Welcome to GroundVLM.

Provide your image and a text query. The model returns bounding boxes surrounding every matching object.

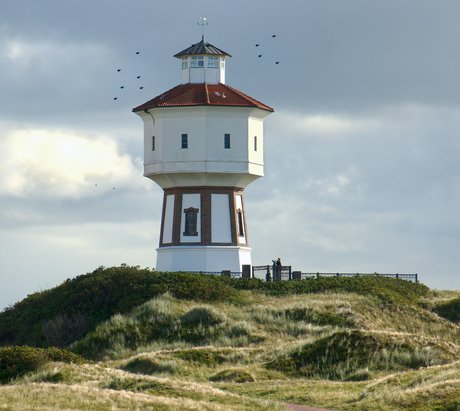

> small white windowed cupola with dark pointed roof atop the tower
[174,37,231,84]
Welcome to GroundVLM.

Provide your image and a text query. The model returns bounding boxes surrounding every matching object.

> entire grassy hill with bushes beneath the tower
[0,266,460,411]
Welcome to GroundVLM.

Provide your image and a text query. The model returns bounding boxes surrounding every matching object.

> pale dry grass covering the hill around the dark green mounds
[0,292,460,411]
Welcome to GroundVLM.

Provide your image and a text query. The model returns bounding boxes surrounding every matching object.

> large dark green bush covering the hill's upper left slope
[0,265,241,347]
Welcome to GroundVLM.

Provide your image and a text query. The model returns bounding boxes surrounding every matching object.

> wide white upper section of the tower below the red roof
[138,106,269,188]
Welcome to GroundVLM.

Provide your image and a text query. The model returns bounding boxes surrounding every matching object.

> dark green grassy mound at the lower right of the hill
[267,330,449,380]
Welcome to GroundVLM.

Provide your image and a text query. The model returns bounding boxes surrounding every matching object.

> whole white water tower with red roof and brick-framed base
[133,38,273,272]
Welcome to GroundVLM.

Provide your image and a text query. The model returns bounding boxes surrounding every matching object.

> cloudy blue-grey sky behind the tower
[0,0,460,310]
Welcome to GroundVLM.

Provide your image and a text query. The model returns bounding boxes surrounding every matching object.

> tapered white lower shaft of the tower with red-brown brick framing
[156,186,251,271]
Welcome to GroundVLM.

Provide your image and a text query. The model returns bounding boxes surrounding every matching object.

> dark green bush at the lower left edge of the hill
[0,346,84,384]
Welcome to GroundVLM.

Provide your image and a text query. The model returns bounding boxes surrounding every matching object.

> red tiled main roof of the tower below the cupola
[133,83,274,112]
